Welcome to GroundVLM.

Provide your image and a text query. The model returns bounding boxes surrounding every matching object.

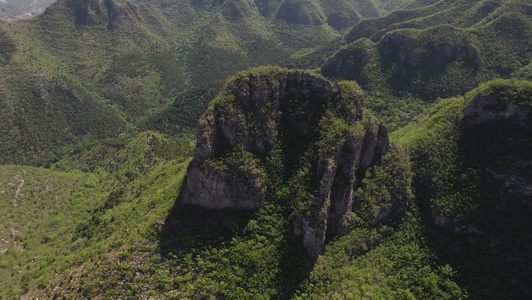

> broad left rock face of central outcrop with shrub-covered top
[182,71,333,209]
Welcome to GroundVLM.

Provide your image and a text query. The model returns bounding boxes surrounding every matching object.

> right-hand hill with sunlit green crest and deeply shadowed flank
[392,79,532,299]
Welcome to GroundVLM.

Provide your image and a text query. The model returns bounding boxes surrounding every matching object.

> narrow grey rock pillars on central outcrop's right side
[294,119,391,257]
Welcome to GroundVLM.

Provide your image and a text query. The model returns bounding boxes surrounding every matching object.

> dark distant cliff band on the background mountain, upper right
[322,26,482,100]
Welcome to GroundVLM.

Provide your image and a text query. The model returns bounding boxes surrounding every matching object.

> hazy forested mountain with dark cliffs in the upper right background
[322,1,532,127]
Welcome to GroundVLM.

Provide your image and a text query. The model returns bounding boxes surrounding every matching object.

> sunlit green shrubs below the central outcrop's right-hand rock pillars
[300,207,468,299]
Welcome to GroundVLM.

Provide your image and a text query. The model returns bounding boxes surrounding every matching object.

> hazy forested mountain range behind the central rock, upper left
[0,0,408,165]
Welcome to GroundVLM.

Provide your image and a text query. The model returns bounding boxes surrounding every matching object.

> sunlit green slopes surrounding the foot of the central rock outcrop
[0,78,525,298]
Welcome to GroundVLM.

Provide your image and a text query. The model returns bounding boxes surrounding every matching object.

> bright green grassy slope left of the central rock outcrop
[0,132,191,297]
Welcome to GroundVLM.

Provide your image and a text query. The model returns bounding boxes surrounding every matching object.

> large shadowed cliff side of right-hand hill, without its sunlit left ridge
[420,79,532,294]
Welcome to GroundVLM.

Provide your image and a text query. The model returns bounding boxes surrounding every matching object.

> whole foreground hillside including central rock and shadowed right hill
[0,69,532,298]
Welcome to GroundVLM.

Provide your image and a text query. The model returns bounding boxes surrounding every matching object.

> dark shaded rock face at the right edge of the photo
[460,87,532,207]
